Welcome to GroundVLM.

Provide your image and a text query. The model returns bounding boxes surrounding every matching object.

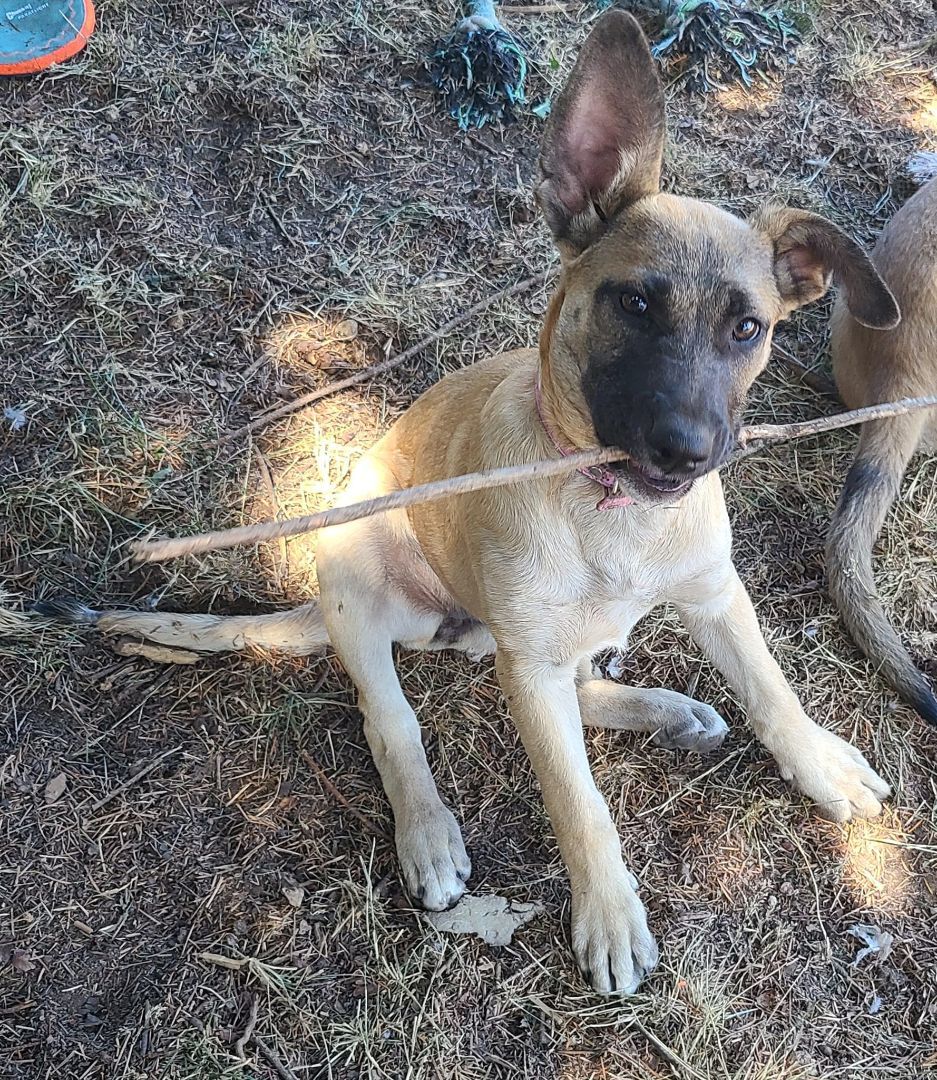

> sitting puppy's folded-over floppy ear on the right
[751,206,901,330]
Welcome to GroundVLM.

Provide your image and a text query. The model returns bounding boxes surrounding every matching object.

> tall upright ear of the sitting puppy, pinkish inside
[537,11,665,259]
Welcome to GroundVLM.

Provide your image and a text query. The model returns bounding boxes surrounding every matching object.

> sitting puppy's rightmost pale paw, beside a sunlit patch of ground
[775,725,892,821]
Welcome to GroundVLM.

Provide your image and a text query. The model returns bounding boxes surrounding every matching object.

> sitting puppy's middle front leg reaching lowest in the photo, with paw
[497,647,657,994]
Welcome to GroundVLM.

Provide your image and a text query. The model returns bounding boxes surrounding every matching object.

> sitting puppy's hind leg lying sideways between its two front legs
[576,661,729,753]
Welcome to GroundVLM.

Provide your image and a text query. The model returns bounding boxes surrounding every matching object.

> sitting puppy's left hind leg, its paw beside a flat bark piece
[323,582,472,912]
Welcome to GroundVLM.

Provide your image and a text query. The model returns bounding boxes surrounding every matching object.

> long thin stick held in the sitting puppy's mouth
[131,396,937,563]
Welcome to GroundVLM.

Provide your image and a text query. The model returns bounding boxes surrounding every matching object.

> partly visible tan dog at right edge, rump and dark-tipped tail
[827,168,937,725]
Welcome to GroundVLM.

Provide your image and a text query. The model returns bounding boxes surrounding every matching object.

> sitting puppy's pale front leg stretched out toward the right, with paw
[675,566,890,821]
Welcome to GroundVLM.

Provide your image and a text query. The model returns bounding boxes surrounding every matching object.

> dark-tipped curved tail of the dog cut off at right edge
[827,413,937,726]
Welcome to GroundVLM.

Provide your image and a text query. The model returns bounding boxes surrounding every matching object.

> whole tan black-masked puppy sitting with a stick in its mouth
[45,11,898,994]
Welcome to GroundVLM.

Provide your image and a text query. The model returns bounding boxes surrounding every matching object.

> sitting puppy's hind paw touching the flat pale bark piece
[396,802,472,912]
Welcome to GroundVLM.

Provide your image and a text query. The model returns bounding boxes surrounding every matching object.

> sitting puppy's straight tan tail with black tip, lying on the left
[33,599,328,656]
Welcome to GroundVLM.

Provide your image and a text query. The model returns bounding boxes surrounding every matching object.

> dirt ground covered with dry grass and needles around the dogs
[0,0,937,1080]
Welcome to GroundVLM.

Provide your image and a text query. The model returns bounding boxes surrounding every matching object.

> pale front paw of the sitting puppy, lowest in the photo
[572,867,657,994]
